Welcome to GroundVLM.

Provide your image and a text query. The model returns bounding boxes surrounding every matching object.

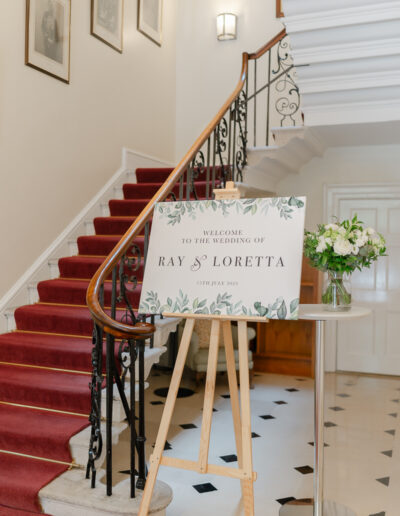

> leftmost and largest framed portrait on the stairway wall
[25,0,71,83]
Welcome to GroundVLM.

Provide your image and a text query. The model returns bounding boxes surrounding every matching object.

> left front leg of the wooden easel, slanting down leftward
[139,319,195,516]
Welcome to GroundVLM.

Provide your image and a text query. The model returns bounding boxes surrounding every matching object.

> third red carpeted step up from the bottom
[0,364,91,414]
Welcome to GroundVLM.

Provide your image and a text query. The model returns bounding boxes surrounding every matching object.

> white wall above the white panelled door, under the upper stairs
[277,145,400,230]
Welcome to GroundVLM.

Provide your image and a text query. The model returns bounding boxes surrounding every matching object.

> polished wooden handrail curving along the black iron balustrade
[86,30,286,339]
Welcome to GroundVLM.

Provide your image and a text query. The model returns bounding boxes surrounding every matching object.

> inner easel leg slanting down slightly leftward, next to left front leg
[199,319,221,473]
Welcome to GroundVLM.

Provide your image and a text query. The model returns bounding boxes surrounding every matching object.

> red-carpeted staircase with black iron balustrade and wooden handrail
[0,27,312,516]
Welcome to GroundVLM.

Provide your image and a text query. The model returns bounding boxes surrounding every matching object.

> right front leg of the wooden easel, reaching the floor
[238,321,254,516]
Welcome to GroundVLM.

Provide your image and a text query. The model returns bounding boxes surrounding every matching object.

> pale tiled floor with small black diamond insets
[111,371,400,516]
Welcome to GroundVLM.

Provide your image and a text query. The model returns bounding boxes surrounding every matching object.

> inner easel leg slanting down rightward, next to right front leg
[222,321,243,474]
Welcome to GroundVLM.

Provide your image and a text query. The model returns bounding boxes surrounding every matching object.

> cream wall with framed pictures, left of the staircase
[0,0,176,297]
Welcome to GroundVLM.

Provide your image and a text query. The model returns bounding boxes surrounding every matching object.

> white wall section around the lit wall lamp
[176,0,283,160]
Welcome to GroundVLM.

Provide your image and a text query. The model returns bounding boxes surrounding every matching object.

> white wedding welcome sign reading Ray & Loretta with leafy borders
[139,197,305,319]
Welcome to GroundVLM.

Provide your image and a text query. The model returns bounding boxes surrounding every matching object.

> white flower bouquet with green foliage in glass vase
[304,215,386,310]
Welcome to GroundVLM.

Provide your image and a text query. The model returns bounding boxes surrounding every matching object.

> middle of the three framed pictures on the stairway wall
[91,0,124,54]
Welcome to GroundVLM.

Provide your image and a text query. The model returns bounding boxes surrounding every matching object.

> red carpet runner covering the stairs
[0,168,206,516]
